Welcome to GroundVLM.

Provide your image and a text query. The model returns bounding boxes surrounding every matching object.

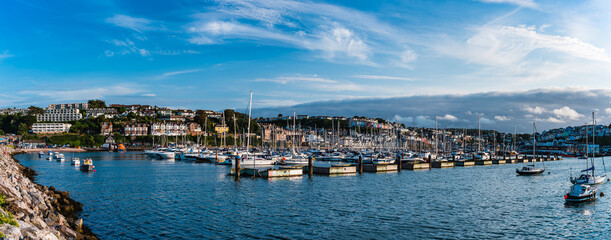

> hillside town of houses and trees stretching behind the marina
[0,100,611,156]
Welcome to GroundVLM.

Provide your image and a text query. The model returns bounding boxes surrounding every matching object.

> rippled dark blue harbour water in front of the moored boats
[16,152,611,239]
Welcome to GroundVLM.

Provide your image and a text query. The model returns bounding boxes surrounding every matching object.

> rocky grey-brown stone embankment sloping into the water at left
[0,147,98,240]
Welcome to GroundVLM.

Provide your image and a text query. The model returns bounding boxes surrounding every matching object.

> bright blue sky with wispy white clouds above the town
[0,0,611,132]
